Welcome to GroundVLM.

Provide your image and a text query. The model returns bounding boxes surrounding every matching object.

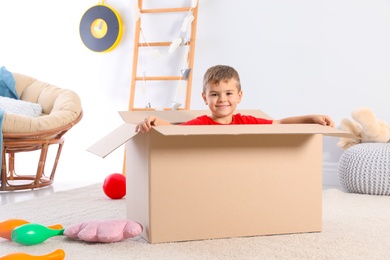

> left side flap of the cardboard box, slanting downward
[87,124,137,158]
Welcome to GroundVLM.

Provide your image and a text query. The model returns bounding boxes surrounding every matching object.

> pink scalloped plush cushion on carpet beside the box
[64,220,143,243]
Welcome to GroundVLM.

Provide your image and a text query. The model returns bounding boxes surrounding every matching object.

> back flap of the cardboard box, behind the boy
[119,110,272,124]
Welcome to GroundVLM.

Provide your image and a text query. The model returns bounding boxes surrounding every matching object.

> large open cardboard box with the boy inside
[88,111,350,243]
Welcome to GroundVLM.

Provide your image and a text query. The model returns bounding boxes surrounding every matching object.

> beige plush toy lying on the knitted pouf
[337,107,390,149]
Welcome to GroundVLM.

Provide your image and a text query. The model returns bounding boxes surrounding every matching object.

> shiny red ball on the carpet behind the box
[103,173,126,199]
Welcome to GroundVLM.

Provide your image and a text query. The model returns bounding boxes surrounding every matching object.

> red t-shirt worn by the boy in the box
[180,114,273,125]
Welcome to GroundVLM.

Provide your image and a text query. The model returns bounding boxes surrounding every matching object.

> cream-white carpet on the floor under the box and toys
[0,184,390,260]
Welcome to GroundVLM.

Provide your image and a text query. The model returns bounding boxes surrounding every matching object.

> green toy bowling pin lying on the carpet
[11,223,64,246]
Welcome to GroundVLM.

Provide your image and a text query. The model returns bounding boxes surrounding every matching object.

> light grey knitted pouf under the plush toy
[338,143,390,195]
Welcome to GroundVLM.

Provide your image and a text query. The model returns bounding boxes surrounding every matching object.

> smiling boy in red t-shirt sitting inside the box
[135,65,334,133]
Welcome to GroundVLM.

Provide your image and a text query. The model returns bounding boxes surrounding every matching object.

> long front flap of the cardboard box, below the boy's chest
[154,124,354,138]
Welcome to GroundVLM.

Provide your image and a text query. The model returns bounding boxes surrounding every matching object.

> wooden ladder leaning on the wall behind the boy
[129,0,198,111]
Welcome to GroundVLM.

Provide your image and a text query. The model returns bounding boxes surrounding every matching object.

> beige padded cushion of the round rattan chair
[3,73,82,133]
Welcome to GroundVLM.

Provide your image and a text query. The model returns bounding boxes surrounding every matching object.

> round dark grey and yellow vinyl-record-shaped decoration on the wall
[80,1,123,52]
